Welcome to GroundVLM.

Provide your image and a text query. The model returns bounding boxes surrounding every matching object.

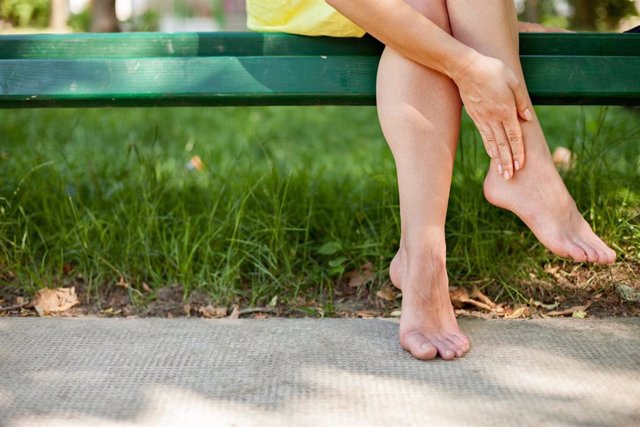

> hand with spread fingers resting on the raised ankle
[453,54,533,180]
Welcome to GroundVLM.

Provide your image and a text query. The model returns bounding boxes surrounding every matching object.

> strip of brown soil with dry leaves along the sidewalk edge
[0,262,640,319]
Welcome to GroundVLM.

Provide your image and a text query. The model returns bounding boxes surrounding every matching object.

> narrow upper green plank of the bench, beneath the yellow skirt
[0,33,640,60]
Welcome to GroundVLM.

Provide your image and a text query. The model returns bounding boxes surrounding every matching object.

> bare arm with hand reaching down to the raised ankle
[327,0,533,176]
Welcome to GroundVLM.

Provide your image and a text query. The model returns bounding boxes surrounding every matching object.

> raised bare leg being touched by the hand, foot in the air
[447,0,615,264]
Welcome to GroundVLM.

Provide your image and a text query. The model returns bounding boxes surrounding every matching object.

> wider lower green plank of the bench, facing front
[0,56,640,108]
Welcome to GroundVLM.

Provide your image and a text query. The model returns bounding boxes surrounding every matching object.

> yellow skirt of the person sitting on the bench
[247,0,365,37]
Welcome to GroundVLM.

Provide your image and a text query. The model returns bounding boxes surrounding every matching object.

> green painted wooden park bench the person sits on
[0,33,640,108]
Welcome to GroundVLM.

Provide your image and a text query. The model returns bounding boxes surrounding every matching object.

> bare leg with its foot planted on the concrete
[377,0,469,359]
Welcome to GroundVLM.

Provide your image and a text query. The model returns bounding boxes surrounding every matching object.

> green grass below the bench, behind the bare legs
[0,107,640,312]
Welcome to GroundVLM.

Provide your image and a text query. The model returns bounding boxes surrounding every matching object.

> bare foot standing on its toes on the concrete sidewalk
[389,245,469,360]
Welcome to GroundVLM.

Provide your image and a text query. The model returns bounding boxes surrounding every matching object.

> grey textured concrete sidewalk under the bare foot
[0,318,640,427]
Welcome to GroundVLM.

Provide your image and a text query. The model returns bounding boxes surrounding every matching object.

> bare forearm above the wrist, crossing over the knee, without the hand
[327,0,478,77]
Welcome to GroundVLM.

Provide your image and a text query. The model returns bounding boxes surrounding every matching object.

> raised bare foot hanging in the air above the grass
[484,118,616,264]
